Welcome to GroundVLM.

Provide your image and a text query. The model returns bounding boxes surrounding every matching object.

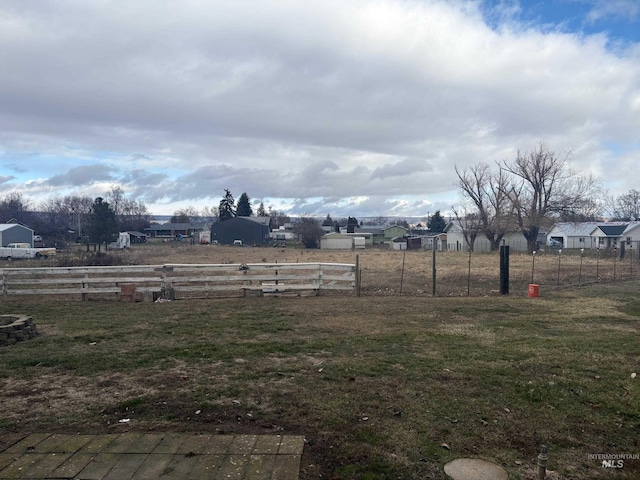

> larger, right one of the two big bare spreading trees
[501,143,599,253]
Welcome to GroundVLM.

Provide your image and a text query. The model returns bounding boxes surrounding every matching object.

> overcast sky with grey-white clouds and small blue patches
[0,0,640,217]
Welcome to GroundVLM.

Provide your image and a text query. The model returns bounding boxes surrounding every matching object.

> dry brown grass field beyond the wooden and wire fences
[58,241,640,296]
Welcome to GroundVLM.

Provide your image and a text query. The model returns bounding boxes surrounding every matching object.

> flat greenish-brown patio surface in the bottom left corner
[0,432,304,480]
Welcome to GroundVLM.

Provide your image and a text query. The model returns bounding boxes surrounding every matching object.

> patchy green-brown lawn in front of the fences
[0,264,640,479]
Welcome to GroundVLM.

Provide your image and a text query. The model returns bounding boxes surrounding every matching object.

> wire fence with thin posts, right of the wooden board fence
[359,249,640,296]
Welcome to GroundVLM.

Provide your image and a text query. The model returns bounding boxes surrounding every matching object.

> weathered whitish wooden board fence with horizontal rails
[0,263,358,300]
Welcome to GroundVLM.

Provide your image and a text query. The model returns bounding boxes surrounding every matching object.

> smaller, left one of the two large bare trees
[454,163,515,252]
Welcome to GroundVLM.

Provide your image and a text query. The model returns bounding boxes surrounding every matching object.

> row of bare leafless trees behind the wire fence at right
[453,143,640,253]
